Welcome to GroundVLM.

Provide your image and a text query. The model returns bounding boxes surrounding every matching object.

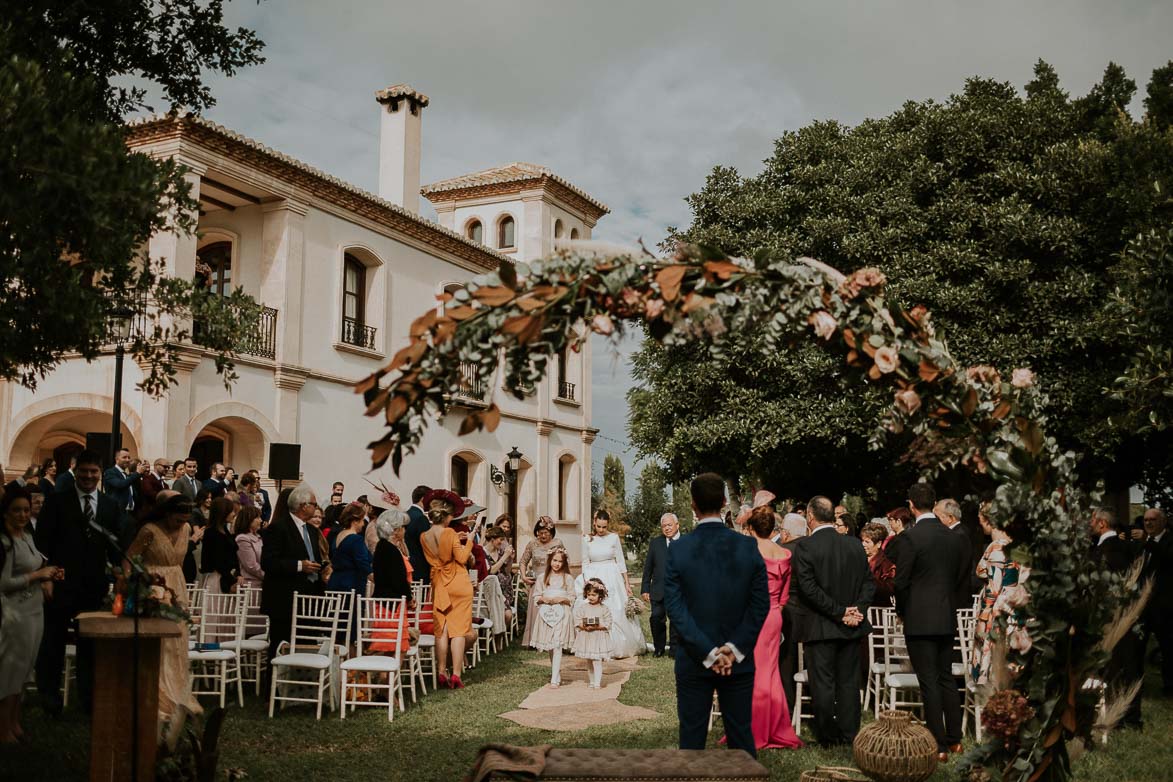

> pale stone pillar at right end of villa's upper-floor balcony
[260,198,308,366]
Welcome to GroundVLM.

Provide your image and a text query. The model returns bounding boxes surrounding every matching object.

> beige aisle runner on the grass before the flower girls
[500,655,659,730]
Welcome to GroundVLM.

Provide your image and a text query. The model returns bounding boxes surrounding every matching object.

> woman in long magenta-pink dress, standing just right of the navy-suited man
[746,506,802,749]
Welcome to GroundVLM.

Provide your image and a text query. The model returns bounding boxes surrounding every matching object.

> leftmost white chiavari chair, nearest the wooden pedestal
[188,592,244,708]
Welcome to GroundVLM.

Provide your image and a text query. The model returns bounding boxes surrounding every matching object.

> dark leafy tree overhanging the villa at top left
[0,0,262,393]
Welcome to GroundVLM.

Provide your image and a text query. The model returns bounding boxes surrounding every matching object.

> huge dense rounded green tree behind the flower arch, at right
[630,62,1173,496]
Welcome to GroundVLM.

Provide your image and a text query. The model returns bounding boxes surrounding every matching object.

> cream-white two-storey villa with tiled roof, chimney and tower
[0,84,608,559]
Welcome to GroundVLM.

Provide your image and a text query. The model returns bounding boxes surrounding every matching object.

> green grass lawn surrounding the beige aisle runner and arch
[9,647,1173,782]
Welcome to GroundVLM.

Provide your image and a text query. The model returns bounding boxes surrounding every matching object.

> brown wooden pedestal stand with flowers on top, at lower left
[77,611,183,782]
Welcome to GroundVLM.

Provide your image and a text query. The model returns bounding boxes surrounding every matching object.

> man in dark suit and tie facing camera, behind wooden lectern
[35,450,123,714]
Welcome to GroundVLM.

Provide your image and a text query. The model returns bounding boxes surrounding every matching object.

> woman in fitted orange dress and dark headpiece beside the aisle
[420,489,473,689]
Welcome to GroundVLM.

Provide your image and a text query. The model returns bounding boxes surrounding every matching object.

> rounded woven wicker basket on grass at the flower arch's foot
[852,712,937,782]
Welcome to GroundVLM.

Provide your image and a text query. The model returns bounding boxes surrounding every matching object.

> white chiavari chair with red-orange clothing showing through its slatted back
[341,598,407,722]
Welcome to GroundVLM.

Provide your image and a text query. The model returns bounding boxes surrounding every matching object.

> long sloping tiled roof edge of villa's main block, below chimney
[127,111,513,268]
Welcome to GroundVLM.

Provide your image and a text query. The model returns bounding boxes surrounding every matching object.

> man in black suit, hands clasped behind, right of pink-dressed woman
[793,497,875,744]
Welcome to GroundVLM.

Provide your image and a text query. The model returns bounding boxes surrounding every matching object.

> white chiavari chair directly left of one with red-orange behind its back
[269,592,341,720]
